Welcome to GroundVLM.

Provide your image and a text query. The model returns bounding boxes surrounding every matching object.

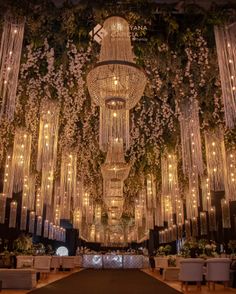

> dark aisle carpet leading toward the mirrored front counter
[29,269,180,294]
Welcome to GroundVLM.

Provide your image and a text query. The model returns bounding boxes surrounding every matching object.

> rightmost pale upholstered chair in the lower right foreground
[206,258,231,290]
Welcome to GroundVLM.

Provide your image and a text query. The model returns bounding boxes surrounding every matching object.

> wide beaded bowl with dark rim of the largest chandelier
[87,60,146,109]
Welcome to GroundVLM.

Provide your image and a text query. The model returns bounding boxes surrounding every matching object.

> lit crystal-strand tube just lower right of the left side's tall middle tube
[60,152,77,219]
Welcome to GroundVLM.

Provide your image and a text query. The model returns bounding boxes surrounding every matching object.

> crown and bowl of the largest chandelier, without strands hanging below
[87,16,146,109]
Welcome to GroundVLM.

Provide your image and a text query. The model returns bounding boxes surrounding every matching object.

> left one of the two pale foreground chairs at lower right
[179,258,204,291]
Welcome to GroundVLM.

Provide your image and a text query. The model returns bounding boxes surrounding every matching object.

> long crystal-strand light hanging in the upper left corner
[0,15,25,121]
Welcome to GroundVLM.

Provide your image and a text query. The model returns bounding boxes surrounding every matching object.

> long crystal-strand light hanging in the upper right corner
[214,22,236,128]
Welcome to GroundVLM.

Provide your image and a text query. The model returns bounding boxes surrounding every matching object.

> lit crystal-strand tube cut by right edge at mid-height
[225,148,236,201]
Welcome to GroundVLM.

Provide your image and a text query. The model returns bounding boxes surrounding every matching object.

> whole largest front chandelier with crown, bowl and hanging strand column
[87,16,146,150]
